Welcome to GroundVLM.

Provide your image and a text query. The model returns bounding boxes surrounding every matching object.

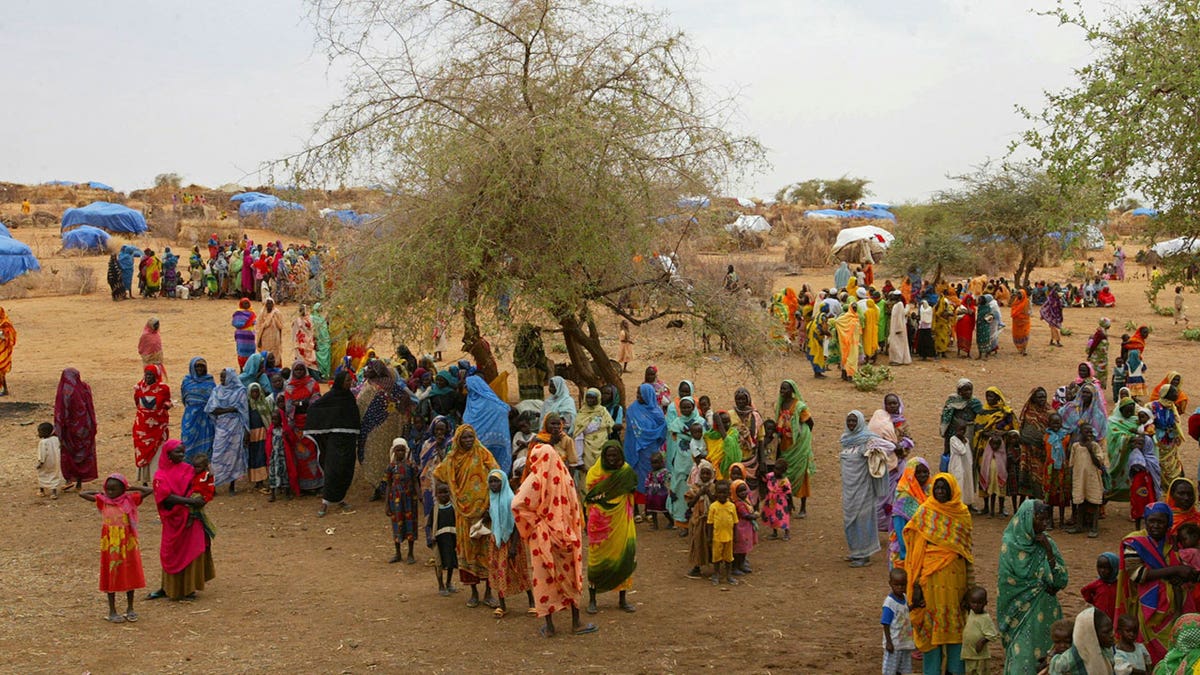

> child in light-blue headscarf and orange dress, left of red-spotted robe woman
[484,468,538,619]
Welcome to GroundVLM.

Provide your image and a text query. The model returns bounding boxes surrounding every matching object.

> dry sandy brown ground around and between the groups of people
[0,223,1200,673]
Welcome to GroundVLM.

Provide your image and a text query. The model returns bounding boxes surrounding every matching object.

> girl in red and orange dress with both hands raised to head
[79,473,154,623]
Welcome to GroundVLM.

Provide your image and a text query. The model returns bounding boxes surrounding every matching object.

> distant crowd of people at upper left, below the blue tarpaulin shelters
[107,233,328,303]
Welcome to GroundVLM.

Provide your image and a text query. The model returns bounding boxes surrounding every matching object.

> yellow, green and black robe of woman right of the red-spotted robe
[583,451,637,593]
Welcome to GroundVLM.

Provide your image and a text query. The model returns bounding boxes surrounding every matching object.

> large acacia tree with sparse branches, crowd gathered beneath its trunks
[288,0,761,386]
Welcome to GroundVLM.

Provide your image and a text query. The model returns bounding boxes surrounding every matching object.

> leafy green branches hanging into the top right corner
[1021,0,1200,240]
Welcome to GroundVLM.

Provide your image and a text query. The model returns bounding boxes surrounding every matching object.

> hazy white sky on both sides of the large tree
[0,0,1118,202]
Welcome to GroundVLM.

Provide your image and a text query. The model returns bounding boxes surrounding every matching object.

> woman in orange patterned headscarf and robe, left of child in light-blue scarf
[433,424,499,607]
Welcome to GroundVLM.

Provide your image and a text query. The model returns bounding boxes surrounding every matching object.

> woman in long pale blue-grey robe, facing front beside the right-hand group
[839,410,895,567]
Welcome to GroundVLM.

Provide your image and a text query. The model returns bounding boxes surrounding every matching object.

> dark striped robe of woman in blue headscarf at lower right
[1117,503,1186,662]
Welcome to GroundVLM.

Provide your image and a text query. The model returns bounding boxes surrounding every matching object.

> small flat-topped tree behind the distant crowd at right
[935,162,1098,285]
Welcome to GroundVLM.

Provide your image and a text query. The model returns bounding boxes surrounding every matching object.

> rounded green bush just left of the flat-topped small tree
[883,204,978,281]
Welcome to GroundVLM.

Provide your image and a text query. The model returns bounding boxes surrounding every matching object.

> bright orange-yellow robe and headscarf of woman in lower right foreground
[904,473,974,652]
